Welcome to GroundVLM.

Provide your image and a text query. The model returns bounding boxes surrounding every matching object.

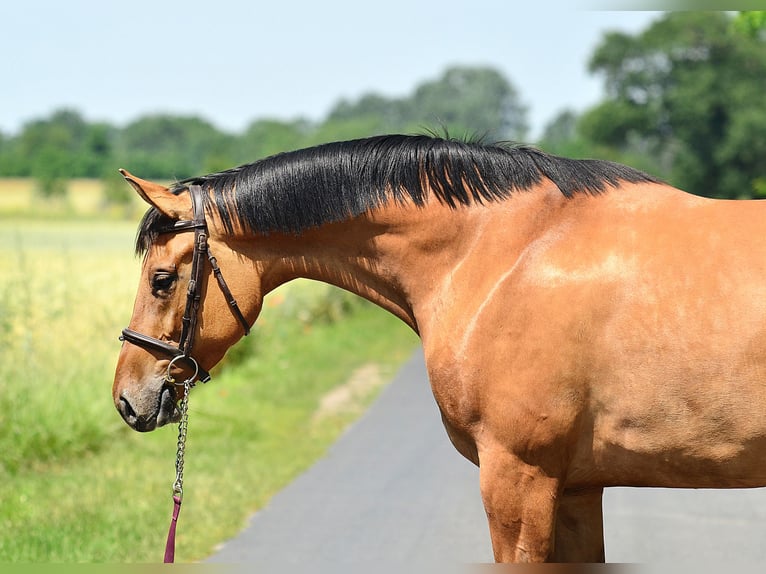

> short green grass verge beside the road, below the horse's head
[0,306,420,562]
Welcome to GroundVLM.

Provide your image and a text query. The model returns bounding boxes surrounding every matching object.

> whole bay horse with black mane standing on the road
[113,135,766,562]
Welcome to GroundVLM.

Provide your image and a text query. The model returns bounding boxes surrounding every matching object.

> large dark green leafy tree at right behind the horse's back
[580,12,766,197]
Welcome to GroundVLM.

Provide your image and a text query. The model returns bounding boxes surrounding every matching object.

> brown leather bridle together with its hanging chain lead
[120,185,250,563]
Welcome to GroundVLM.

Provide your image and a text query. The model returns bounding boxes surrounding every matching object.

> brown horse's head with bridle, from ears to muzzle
[112,172,261,431]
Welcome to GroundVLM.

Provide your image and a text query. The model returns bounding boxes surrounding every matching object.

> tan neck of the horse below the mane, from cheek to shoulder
[251,185,570,336]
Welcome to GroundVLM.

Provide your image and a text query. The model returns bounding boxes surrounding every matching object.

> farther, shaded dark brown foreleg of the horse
[552,488,604,562]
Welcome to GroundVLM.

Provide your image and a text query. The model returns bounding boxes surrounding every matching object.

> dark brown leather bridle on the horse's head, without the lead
[120,185,250,383]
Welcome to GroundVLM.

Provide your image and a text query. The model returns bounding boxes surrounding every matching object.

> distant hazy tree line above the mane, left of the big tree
[0,67,526,200]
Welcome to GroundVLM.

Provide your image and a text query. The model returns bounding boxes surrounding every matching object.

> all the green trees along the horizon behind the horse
[0,12,766,201]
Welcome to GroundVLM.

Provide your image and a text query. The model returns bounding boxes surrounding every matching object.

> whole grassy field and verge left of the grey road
[0,181,417,562]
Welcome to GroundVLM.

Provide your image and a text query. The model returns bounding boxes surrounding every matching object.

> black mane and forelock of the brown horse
[136,135,657,253]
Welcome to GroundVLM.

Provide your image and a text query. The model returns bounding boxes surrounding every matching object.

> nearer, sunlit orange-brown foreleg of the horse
[479,449,559,562]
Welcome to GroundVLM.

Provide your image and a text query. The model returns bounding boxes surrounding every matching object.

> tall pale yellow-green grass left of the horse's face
[0,221,138,472]
